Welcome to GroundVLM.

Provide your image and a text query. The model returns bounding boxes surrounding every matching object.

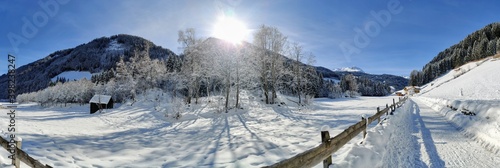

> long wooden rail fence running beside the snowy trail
[266,97,408,168]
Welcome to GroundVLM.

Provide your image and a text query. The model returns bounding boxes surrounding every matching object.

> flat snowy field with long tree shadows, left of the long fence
[0,97,394,167]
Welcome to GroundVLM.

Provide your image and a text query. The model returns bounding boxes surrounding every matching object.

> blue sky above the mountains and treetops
[0,0,500,75]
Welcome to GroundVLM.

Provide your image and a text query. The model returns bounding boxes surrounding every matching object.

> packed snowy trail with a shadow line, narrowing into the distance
[412,99,500,167]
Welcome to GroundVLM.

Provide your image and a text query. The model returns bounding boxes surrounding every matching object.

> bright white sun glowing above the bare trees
[213,17,248,44]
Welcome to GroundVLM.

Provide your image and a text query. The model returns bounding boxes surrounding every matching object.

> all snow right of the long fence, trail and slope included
[324,58,500,167]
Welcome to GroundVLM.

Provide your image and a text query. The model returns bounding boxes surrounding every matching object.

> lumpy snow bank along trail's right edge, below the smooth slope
[419,97,500,153]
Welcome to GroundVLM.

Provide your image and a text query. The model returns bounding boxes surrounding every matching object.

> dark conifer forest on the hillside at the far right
[410,23,500,86]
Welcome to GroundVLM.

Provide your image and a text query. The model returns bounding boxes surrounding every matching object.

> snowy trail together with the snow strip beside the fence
[332,98,500,168]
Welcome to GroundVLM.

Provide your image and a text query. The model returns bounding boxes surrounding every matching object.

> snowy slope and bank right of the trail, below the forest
[419,57,500,153]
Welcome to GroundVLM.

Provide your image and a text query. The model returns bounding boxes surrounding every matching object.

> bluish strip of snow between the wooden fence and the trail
[330,98,419,167]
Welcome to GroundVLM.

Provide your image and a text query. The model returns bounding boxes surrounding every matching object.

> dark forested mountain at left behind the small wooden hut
[0,34,175,99]
